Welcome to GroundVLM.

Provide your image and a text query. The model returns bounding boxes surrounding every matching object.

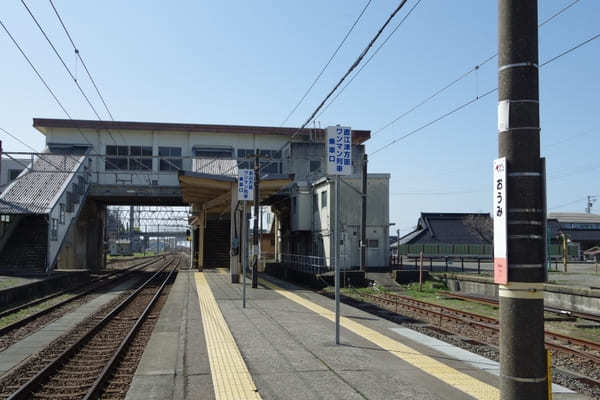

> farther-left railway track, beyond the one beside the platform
[0,257,165,351]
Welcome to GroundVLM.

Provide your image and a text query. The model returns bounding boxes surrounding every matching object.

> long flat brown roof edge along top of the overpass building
[33,118,371,144]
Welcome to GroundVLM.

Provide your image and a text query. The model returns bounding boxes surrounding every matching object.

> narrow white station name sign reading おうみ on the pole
[492,157,508,285]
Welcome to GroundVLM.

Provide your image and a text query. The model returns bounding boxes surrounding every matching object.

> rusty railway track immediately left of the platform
[0,257,181,399]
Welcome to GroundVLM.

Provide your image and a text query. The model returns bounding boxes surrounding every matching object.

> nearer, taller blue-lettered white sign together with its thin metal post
[325,125,352,344]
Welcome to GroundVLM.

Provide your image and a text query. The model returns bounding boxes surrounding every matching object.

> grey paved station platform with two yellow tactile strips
[127,270,586,400]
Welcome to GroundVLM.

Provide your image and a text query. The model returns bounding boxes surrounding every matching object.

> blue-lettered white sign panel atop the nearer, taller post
[325,125,352,175]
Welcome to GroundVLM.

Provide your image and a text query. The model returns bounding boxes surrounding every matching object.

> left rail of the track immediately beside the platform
[9,260,174,400]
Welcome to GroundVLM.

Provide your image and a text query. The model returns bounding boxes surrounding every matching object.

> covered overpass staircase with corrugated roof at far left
[0,152,91,275]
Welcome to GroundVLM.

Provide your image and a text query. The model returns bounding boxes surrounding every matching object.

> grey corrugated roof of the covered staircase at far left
[0,153,85,214]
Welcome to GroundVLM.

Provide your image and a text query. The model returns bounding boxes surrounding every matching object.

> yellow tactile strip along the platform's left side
[196,272,261,400]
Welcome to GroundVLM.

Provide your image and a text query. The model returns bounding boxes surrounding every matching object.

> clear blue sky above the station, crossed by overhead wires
[0,0,600,234]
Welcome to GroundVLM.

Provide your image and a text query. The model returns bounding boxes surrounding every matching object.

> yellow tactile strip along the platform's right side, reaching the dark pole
[260,279,500,400]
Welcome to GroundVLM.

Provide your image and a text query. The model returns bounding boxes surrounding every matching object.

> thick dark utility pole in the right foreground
[498,0,551,400]
